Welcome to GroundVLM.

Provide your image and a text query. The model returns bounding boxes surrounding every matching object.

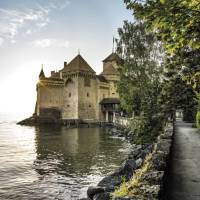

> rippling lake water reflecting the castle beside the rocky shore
[0,114,130,200]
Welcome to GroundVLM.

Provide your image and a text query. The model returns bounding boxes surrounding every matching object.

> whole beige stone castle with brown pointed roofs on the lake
[35,53,122,122]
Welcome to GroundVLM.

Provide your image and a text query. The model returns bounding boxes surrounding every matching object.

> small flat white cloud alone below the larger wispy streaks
[32,38,69,48]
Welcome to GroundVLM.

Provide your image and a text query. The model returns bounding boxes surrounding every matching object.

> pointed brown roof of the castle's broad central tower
[62,55,95,74]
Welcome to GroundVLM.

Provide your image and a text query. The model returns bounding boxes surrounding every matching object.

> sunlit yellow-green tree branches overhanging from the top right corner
[124,0,200,89]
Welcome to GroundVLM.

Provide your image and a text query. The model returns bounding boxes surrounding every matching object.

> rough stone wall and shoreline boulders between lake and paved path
[82,123,173,200]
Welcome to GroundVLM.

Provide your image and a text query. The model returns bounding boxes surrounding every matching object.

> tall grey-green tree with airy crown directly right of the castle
[117,21,163,143]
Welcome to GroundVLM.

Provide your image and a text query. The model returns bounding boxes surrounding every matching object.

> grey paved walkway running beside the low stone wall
[164,121,200,200]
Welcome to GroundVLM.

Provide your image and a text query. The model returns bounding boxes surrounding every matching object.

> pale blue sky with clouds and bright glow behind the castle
[0,0,133,118]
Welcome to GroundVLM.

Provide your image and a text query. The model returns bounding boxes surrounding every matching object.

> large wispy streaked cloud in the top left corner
[0,0,70,41]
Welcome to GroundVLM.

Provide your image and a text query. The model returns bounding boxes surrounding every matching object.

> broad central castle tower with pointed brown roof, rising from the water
[62,55,97,120]
